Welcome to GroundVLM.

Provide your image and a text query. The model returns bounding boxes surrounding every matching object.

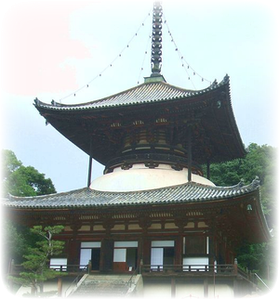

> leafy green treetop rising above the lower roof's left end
[0,149,56,197]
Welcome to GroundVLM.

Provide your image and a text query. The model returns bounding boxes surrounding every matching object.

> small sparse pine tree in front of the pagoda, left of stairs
[8,226,64,296]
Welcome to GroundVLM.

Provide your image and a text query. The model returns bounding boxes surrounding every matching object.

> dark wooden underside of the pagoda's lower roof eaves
[2,185,270,246]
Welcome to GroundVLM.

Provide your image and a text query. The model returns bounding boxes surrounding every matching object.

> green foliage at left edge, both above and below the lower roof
[0,149,56,274]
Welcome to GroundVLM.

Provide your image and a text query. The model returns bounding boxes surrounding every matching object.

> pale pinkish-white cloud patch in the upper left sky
[1,1,90,96]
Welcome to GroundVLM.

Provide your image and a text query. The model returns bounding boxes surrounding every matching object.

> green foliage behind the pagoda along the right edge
[210,143,279,279]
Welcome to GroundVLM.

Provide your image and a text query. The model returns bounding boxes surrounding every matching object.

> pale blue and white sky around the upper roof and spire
[0,0,278,192]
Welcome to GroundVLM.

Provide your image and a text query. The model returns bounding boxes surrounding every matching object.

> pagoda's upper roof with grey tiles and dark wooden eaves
[35,76,245,165]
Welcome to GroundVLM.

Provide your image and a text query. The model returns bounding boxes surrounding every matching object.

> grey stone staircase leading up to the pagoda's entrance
[67,275,135,299]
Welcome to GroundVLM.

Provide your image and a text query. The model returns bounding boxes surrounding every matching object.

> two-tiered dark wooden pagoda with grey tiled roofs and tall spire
[0,0,270,299]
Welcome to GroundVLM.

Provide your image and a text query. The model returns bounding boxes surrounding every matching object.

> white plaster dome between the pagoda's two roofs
[90,164,215,192]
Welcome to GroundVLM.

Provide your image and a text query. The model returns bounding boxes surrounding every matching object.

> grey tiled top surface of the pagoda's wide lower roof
[0,180,259,209]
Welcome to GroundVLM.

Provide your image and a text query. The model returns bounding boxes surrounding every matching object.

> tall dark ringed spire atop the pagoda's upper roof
[151,0,163,77]
